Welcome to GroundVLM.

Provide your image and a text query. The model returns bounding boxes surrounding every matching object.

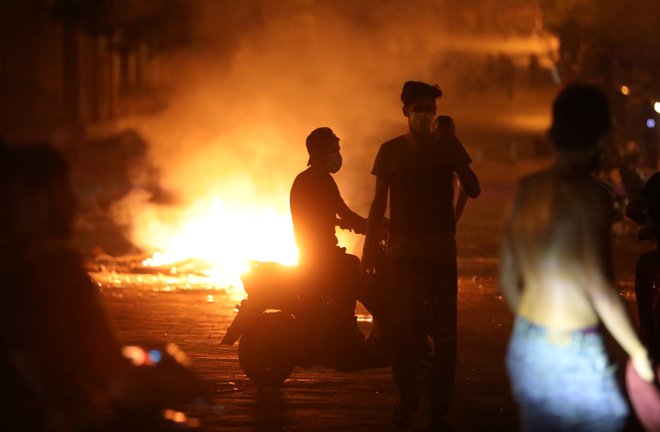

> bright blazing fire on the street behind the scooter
[134,196,298,288]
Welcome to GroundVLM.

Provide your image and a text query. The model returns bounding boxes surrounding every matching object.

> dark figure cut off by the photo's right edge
[635,173,660,362]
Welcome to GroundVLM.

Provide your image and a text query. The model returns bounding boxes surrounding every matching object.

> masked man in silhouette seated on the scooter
[290,127,367,332]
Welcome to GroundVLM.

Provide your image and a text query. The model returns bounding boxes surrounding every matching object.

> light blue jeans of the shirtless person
[506,318,629,432]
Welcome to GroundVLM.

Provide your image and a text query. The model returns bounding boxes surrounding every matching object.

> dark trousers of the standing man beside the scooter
[387,255,458,415]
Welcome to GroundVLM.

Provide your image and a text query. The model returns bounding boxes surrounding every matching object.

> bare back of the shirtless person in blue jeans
[509,170,611,330]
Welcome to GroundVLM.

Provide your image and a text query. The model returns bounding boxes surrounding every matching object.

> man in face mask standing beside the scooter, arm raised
[362,81,480,427]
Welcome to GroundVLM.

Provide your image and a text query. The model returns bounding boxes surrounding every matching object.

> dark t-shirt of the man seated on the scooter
[290,167,342,260]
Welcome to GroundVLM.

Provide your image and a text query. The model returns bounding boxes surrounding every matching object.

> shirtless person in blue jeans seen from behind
[500,84,653,431]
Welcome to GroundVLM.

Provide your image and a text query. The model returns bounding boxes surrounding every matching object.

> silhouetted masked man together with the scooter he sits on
[221,127,387,386]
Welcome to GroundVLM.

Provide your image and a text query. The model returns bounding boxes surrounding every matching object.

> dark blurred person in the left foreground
[0,144,128,431]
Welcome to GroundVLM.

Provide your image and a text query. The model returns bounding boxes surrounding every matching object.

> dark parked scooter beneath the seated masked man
[221,242,389,386]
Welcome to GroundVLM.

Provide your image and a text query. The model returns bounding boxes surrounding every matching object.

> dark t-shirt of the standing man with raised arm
[372,135,472,237]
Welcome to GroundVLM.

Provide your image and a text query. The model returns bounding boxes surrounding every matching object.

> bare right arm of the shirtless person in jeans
[580,191,654,381]
